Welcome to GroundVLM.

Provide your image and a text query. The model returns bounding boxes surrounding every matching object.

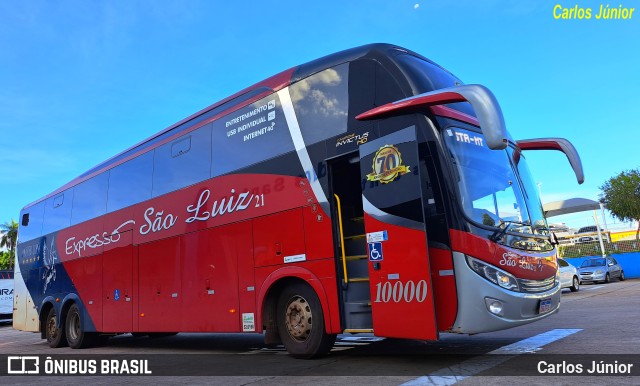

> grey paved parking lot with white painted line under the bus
[0,280,640,385]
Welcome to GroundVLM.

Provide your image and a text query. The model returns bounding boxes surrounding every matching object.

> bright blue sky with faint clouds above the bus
[0,0,640,231]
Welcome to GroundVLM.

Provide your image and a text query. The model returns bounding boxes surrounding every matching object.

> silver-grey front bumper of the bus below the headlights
[450,252,561,334]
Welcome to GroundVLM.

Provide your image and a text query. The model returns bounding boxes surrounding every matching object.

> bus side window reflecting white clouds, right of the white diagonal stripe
[289,63,349,145]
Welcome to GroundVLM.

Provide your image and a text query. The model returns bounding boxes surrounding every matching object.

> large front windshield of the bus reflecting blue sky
[444,128,548,241]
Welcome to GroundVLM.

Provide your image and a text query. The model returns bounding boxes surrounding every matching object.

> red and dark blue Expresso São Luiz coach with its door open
[14,44,583,358]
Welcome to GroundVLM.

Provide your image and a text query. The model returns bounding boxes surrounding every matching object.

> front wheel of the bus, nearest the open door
[276,283,336,359]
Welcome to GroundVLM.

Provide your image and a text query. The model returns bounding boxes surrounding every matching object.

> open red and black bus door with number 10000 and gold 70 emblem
[359,126,438,340]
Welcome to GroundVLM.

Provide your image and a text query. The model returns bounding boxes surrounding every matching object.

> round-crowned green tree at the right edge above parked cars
[600,169,640,240]
